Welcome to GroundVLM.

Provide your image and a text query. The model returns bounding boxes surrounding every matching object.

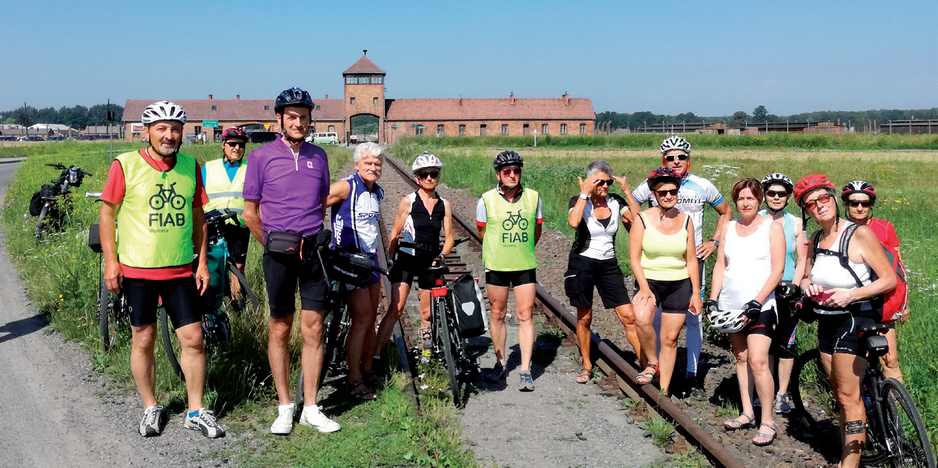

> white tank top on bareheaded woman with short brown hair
[719,218,775,310]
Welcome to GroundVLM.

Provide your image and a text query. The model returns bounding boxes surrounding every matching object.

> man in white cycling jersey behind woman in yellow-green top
[620,135,733,380]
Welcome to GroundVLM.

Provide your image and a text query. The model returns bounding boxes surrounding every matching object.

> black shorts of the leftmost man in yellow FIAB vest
[123,276,204,328]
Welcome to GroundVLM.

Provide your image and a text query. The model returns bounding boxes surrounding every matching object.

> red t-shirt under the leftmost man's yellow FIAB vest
[101,149,208,280]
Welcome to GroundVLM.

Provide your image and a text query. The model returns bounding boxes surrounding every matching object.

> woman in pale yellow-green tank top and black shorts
[629,167,702,394]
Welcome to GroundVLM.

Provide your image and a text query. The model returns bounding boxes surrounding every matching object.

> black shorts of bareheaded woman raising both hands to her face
[563,253,629,309]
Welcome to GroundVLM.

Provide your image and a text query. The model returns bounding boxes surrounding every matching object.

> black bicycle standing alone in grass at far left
[29,163,91,245]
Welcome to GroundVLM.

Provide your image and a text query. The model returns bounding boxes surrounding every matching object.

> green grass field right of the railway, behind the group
[393,135,938,441]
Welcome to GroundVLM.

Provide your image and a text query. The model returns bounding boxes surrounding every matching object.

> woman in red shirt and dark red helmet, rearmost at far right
[840,180,909,382]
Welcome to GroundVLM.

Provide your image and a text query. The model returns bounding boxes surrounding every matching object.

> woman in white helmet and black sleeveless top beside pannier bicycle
[374,151,453,368]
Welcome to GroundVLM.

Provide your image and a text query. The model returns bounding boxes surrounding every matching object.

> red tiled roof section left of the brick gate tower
[123,99,345,122]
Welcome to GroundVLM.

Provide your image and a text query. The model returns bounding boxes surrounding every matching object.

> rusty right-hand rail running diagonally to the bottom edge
[376,157,747,468]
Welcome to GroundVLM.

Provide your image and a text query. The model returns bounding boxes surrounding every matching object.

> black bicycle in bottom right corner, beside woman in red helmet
[791,323,935,468]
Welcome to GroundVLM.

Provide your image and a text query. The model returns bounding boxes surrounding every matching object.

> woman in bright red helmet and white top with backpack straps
[794,174,896,468]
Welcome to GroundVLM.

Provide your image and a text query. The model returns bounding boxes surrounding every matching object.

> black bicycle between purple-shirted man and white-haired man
[295,229,388,407]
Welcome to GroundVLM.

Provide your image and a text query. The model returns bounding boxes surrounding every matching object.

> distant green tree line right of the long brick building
[595,106,938,130]
